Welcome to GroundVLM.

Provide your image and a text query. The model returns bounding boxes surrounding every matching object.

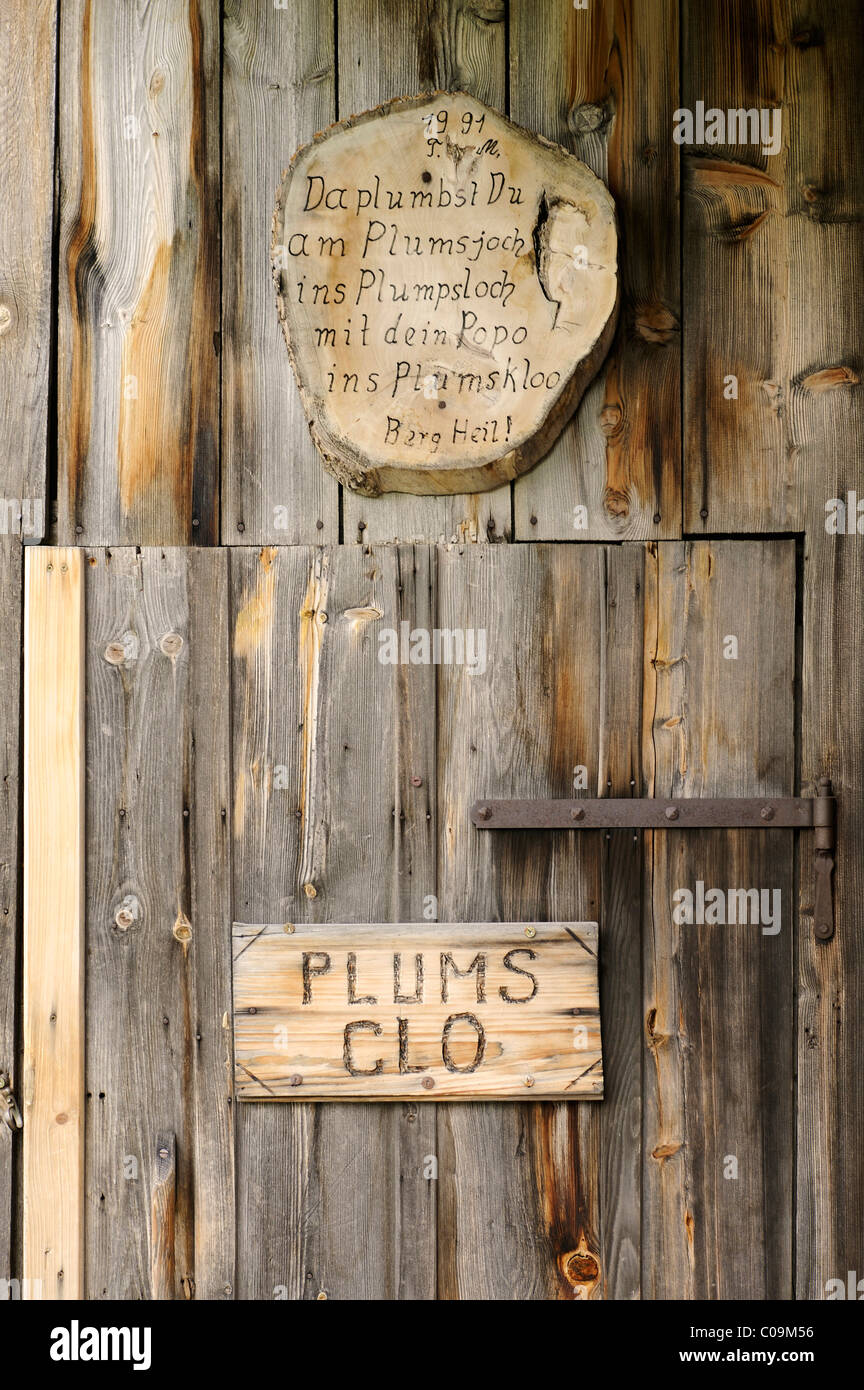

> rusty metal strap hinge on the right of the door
[471,777,836,941]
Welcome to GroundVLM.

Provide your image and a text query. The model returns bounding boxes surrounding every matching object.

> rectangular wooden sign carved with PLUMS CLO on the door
[233,922,603,1101]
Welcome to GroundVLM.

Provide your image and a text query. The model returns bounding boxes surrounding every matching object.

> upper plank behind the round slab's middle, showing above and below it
[338,0,511,542]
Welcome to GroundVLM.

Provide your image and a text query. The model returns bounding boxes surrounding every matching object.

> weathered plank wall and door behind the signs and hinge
[0,0,864,1300]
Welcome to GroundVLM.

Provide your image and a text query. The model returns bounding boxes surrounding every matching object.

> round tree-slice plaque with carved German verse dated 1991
[272,93,618,496]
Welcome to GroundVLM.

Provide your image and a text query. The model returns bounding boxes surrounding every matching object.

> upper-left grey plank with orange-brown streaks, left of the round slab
[57,0,221,545]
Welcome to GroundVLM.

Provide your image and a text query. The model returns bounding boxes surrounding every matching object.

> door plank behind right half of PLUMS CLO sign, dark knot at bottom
[438,546,608,1300]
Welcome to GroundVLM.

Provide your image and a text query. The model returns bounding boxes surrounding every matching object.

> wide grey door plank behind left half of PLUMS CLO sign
[232,546,438,1298]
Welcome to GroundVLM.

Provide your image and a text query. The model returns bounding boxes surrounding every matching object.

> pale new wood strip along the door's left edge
[22,548,85,1298]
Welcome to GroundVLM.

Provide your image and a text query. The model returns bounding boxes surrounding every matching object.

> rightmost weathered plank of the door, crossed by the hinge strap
[643,541,795,1300]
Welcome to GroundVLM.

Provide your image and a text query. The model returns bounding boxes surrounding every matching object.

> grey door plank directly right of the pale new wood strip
[86,549,235,1298]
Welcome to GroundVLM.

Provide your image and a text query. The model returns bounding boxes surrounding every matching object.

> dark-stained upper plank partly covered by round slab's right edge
[510,0,681,541]
